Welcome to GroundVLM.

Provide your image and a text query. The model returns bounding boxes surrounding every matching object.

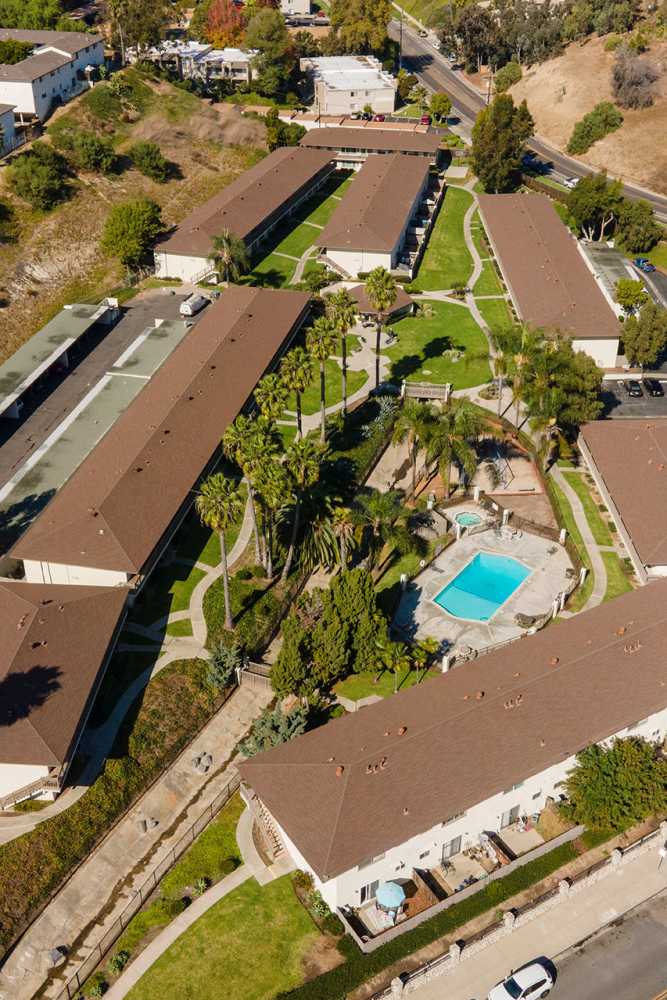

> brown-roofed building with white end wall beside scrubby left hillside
[155,146,335,281]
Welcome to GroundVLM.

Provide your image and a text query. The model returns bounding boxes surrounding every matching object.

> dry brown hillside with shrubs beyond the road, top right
[511,38,667,194]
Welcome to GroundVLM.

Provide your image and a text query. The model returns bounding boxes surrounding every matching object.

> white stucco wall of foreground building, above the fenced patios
[268,704,667,909]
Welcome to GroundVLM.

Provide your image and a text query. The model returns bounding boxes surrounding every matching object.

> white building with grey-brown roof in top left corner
[0,28,104,121]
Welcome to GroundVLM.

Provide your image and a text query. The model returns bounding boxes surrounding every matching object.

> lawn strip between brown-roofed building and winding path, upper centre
[412,187,473,292]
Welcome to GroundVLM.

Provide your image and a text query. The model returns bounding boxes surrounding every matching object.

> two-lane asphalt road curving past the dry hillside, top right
[389,20,667,223]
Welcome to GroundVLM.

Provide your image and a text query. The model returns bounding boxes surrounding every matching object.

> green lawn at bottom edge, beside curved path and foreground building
[128,876,319,1000]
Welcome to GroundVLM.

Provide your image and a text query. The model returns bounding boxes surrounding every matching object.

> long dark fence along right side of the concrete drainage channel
[56,775,241,1000]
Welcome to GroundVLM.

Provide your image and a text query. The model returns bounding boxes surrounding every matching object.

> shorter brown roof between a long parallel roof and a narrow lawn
[317,153,429,252]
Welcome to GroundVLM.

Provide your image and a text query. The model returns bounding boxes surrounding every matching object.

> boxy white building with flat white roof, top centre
[300,56,396,115]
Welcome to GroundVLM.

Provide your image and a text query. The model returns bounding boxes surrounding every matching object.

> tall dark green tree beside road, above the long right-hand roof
[472,94,534,194]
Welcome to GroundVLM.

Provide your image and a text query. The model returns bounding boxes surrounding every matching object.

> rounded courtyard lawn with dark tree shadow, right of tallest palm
[384,302,491,389]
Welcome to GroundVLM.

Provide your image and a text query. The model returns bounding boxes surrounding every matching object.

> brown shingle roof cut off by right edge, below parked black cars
[581,419,667,566]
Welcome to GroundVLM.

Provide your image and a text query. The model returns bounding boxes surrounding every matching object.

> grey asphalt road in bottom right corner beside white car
[551,893,667,1000]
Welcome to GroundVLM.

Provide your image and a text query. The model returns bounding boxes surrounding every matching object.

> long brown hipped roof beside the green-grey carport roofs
[12,287,309,574]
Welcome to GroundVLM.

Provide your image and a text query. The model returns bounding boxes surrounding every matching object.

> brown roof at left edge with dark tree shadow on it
[0,581,127,767]
